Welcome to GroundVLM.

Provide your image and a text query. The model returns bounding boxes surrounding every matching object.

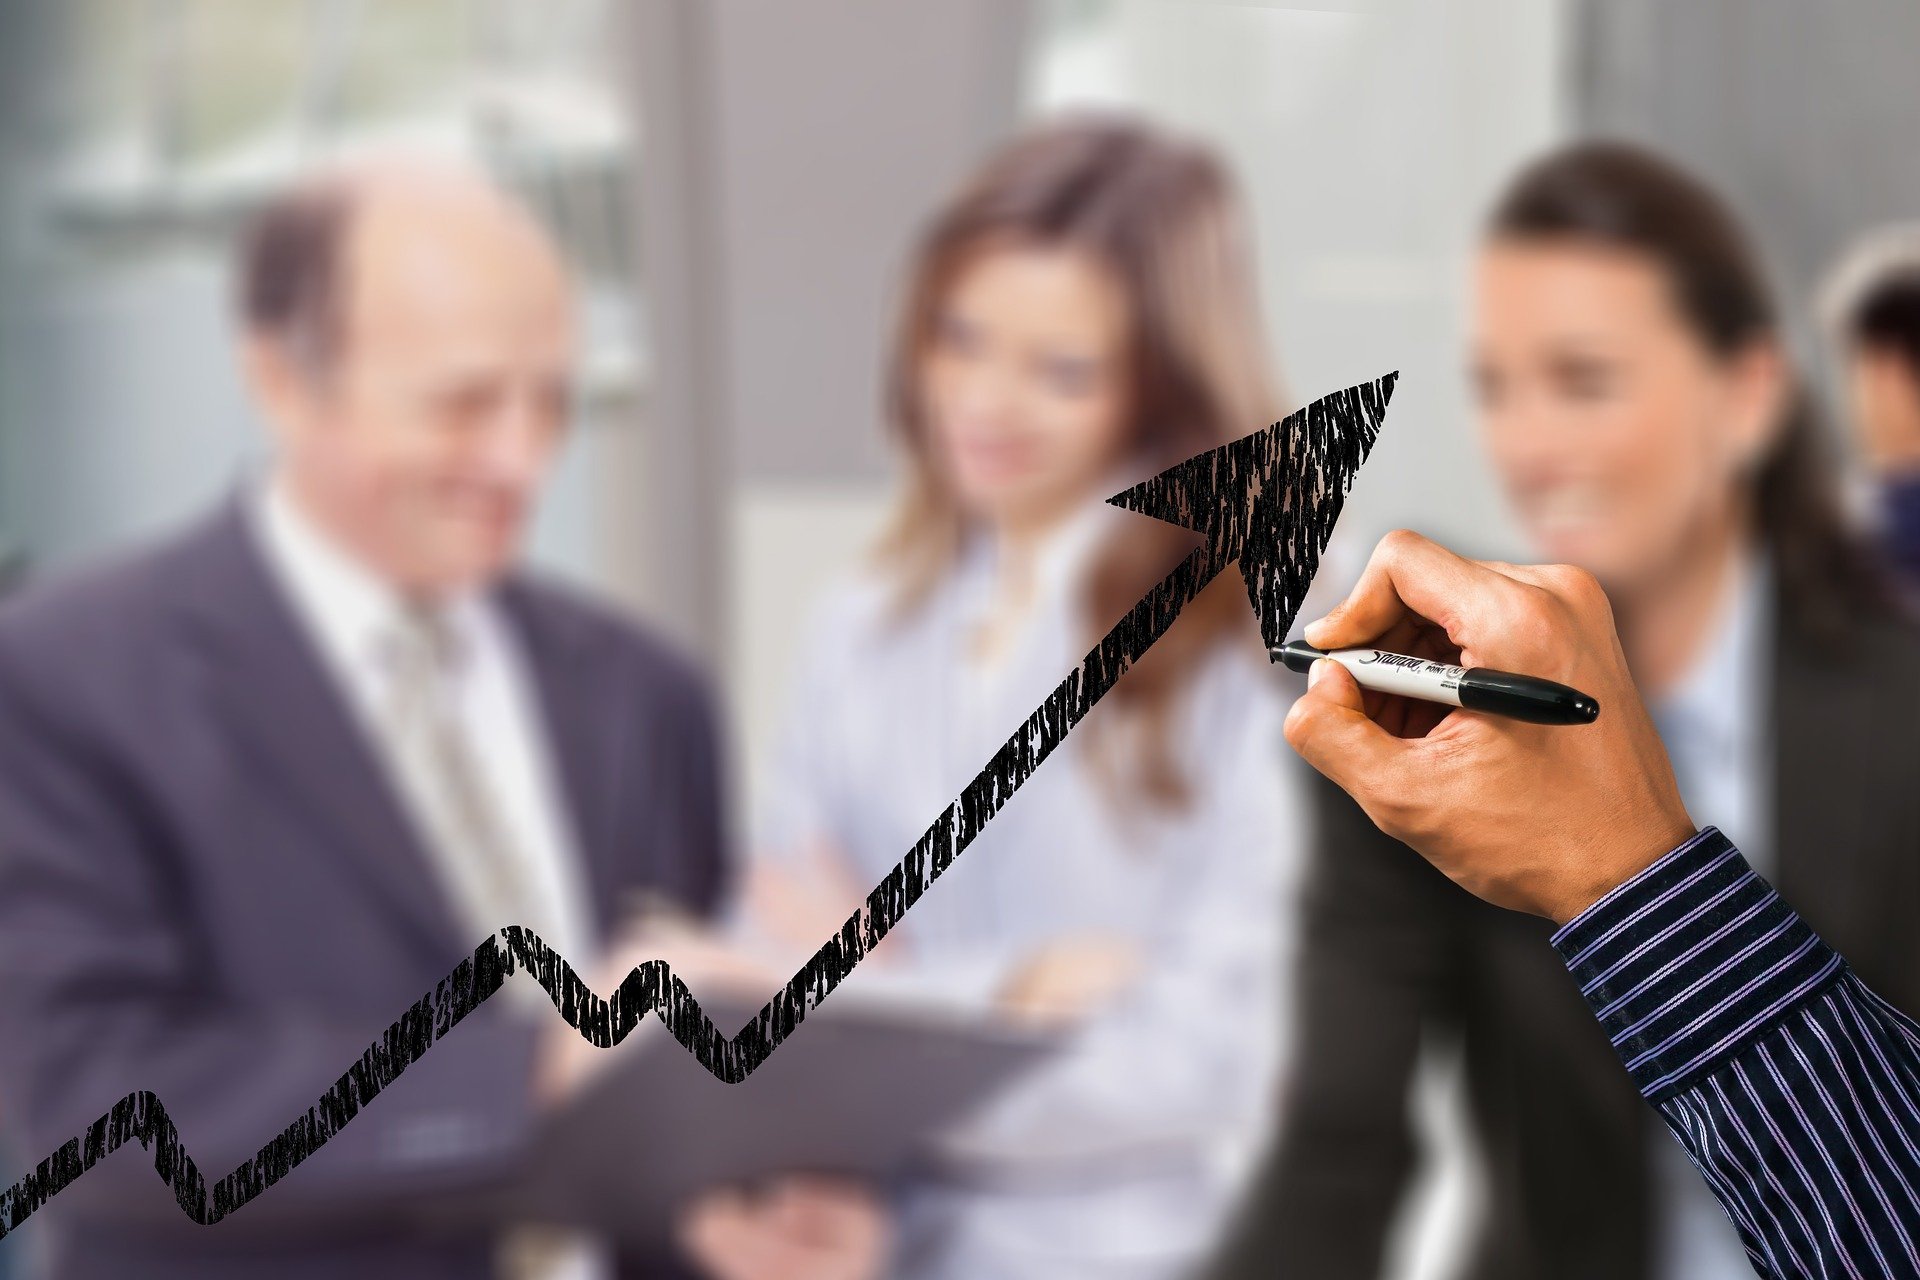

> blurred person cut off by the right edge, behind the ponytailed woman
[1824,223,1920,593]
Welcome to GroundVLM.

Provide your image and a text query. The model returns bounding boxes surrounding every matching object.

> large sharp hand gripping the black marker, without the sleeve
[1286,532,1693,921]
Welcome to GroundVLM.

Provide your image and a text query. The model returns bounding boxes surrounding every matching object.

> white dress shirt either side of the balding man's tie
[250,478,612,1280]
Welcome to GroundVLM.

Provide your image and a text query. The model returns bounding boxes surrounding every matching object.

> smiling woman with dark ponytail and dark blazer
[1219,142,1920,1280]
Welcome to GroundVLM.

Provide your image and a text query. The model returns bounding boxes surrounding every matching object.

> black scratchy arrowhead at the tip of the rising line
[1106,372,1400,649]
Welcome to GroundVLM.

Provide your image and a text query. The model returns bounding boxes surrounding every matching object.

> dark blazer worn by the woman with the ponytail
[1215,594,1920,1280]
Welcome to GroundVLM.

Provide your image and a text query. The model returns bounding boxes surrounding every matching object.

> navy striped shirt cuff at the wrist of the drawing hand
[1553,827,1843,1103]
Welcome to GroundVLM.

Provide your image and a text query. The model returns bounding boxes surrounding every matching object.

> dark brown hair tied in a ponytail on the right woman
[1486,142,1895,643]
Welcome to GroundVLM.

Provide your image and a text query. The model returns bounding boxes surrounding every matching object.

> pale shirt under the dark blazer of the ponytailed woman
[1647,557,1774,1280]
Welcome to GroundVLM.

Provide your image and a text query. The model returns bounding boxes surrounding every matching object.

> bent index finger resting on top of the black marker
[1306,530,1524,649]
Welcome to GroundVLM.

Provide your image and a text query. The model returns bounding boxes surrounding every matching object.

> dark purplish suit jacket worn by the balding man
[0,501,724,1280]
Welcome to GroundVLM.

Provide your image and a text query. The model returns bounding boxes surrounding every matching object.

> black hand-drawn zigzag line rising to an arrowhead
[0,374,1398,1240]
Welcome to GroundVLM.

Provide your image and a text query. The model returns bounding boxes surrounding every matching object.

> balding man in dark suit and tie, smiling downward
[0,163,881,1280]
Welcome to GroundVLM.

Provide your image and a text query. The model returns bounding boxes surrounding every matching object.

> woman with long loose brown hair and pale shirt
[749,117,1294,1280]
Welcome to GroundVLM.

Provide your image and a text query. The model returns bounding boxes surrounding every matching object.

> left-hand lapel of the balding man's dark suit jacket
[184,497,464,956]
